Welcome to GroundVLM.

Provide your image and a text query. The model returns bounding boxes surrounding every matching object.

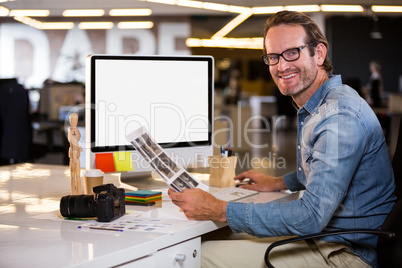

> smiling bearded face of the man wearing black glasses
[265,25,318,97]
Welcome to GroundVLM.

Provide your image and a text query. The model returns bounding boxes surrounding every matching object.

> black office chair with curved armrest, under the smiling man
[264,118,402,268]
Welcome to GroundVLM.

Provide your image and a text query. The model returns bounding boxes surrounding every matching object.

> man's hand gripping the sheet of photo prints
[168,188,227,222]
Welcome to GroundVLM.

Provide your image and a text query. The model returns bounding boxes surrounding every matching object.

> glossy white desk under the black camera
[0,164,296,268]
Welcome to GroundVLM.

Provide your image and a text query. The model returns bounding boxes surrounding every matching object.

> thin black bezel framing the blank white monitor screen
[89,55,214,153]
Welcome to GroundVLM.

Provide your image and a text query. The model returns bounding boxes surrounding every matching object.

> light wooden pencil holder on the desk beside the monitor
[208,155,237,187]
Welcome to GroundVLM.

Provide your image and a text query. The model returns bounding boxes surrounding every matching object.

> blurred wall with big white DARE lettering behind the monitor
[0,17,191,88]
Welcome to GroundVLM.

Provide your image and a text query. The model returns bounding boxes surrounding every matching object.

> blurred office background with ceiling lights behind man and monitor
[0,0,402,178]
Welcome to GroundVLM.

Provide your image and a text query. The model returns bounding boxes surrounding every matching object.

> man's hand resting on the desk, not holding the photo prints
[233,170,287,192]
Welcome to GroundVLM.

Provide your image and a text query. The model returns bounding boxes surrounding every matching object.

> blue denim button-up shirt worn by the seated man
[227,76,396,267]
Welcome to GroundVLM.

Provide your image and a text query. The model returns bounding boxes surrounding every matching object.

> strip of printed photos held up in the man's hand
[126,127,209,192]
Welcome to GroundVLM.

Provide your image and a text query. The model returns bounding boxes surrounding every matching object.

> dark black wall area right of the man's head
[326,16,402,92]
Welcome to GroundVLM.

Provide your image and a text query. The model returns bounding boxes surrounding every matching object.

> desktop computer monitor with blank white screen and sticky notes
[85,55,214,178]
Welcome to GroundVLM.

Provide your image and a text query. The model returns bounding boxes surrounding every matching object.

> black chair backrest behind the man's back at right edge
[377,118,402,267]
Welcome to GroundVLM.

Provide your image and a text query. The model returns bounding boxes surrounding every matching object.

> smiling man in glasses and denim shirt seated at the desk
[169,11,395,267]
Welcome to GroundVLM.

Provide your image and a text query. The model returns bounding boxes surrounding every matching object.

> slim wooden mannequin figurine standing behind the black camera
[68,113,82,195]
